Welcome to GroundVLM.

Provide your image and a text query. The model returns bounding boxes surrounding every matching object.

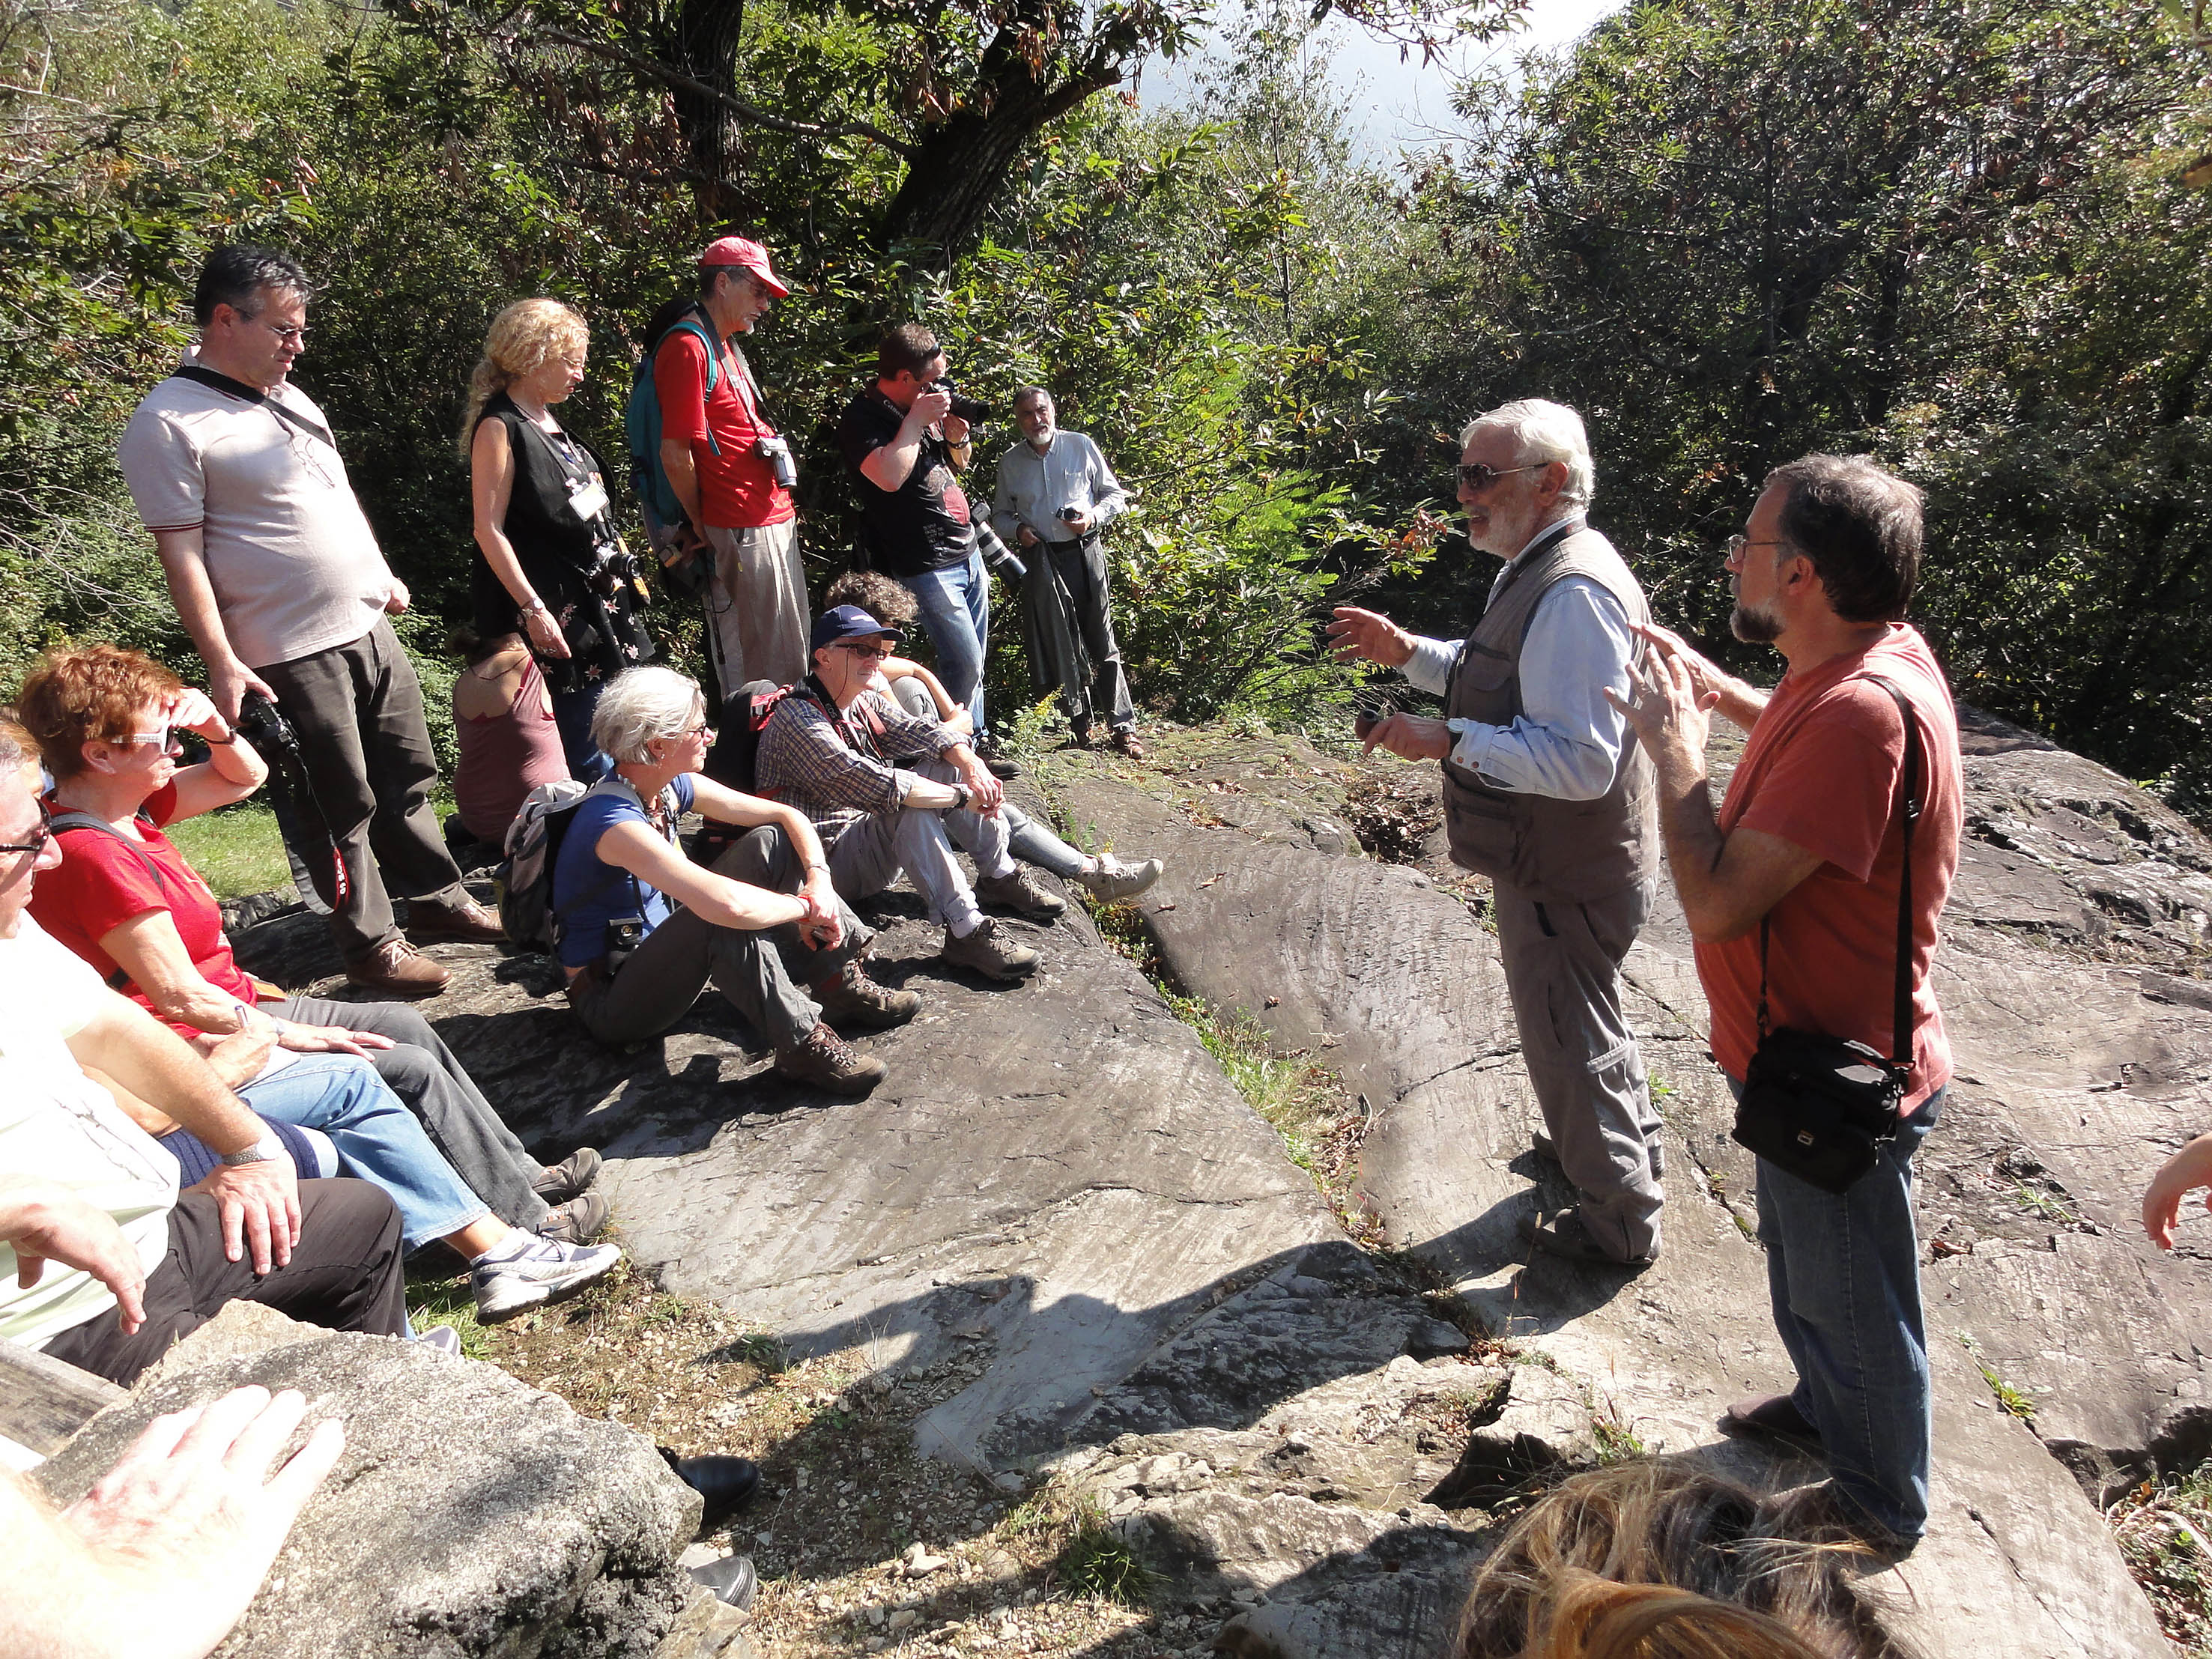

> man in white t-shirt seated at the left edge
[0,735,407,1383]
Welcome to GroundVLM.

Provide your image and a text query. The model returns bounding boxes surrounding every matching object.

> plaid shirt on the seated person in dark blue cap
[754,688,965,852]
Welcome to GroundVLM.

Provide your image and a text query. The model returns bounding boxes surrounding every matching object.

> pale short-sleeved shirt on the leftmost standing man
[118,360,392,668]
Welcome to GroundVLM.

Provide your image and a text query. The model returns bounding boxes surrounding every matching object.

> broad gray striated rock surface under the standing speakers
[211,726,2212,1659]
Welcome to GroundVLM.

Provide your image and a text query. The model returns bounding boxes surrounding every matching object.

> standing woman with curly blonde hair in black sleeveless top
[462,299,652,779]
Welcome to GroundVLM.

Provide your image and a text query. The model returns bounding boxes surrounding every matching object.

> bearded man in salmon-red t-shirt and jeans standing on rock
[1606,455,1962,1553]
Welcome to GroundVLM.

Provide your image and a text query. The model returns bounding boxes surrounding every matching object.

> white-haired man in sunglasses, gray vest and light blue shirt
[1330,398,1664,1270]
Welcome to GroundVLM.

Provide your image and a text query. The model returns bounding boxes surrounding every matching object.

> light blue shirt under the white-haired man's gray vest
[1407,521,1637,801]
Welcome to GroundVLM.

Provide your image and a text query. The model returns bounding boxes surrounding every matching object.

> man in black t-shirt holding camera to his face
[838,323,1000,772]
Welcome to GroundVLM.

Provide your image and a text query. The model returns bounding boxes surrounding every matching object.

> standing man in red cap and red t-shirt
[652,237,807,694]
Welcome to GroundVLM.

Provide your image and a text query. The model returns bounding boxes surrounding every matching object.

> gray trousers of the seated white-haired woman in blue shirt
[575,825,873,1049]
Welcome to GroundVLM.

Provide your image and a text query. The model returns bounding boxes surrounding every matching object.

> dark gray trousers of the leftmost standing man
[255,622,467,967]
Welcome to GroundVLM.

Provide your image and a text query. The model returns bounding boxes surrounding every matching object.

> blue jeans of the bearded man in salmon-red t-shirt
[1730,1079,1945,1540]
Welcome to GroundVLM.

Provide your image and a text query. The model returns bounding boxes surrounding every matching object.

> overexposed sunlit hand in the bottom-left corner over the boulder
[62,1387,345,1659]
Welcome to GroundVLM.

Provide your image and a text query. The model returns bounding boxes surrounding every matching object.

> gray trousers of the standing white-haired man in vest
[1495,880,1666,1261]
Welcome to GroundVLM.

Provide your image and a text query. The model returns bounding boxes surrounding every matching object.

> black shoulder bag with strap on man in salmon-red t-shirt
[1734,675,1920,1192]
